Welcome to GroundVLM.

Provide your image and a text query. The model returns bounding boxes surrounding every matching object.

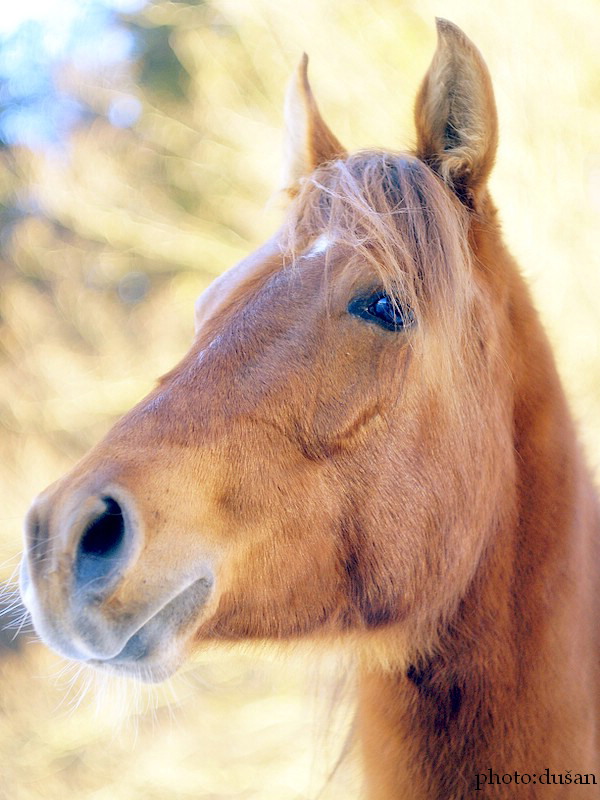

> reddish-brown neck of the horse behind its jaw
[358,214,600,800]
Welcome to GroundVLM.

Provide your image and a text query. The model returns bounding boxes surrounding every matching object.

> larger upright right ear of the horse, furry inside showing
[415,18,498,208]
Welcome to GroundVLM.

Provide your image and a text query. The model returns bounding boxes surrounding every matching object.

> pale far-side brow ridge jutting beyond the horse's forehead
[194,236,281,331]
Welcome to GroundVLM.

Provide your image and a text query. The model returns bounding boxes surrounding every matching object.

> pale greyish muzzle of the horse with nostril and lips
[20,485,214,681]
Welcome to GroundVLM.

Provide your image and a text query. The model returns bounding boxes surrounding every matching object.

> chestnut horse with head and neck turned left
[22,20,600,800]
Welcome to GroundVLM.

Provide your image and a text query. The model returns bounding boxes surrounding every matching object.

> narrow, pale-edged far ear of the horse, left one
[283,53,346,194]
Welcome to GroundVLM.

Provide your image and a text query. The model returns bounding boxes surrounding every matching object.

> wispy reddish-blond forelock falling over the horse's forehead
[282,149,486,394]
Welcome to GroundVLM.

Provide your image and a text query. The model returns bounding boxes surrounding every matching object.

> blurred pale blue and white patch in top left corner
[0,0,145,150]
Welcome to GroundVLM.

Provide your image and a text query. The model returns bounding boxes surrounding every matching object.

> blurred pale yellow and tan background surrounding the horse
[0,0,600,800]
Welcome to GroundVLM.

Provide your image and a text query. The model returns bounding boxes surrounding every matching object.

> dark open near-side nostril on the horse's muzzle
[75,497,126,583]
